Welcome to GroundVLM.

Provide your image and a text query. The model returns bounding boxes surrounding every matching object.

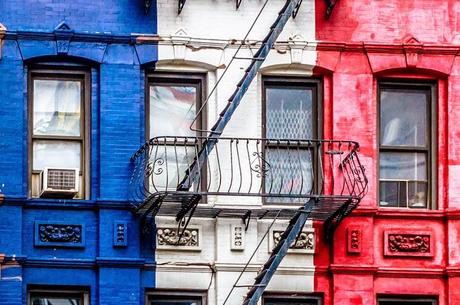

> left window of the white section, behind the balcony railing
[146,73,206,190]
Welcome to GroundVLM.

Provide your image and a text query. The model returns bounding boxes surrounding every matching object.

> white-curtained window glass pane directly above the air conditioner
[33,140,81,170]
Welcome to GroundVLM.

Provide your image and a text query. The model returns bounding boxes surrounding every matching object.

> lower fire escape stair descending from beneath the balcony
[243,198,317,305]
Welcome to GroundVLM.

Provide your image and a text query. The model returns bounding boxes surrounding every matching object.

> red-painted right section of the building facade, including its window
[315,0,460,305]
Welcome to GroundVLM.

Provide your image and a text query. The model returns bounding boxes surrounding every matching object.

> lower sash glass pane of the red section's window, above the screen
[380,152,427,181]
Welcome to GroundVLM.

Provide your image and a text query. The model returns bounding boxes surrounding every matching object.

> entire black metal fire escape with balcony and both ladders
[130,0,368,305]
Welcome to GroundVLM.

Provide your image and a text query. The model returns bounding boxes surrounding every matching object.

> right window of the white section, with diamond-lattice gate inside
[262,77,320,204]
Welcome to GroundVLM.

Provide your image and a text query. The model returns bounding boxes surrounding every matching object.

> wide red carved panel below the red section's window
[384,230,434,257]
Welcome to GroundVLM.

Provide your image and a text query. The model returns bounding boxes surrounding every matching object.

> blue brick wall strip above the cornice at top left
[0,0,157,34]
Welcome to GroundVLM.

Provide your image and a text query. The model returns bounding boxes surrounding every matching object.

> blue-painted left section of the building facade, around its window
[0,0,157,305]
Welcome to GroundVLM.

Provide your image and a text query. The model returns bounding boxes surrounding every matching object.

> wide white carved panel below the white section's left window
[155,227,201,251]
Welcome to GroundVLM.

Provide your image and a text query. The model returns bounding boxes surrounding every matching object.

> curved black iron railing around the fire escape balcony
[130,137,368,205]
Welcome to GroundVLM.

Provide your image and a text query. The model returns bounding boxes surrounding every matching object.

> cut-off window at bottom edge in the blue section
[28,289,89,305]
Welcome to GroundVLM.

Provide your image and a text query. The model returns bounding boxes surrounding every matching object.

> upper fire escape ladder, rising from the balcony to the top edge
[178,0,301,190]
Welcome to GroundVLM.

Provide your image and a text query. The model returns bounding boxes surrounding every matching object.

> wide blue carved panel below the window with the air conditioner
[35,221,85,247]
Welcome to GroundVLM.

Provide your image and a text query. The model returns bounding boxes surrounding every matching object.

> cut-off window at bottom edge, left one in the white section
[145,291,206,305]
